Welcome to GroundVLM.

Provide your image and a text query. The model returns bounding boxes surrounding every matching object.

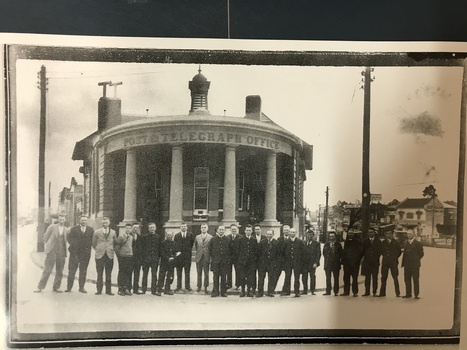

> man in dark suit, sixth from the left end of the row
[141,222,161,295]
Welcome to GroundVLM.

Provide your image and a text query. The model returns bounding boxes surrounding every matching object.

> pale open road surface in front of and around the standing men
[14,225,456,333]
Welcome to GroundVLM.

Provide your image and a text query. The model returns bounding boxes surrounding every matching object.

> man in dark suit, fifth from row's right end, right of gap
[323,232,342,296]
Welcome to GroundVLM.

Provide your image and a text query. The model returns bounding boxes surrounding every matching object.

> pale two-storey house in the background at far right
[395,197,444,244]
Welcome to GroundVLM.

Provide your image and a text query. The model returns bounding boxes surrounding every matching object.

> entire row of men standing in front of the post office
[35,215,423,299]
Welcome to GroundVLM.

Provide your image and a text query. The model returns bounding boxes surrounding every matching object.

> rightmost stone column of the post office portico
[261,152,281,237]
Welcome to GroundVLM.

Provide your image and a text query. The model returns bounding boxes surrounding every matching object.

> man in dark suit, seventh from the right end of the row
[281,228,304,298]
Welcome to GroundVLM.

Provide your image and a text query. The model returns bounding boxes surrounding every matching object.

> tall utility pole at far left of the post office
[37,66,47,252]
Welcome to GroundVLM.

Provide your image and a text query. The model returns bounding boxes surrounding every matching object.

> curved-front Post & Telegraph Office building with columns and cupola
[72,70,312,236]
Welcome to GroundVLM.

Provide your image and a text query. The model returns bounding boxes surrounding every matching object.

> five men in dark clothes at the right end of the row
[323,228,424,299]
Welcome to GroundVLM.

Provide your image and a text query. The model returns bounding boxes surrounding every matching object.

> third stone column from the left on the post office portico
[222,146,238,231]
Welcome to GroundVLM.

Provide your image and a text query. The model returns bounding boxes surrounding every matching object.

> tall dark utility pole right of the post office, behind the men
[362,67,373,236]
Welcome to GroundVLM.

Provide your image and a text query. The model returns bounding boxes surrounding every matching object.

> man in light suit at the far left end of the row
[34,214,69,293]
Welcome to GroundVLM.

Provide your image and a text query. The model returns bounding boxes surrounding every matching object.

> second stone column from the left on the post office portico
[164,145,183,233]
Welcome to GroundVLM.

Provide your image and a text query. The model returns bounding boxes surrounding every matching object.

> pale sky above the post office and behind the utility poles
[16,60,462,215]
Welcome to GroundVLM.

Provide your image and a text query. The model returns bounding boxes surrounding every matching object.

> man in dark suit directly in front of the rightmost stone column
[257,229,279,298]
